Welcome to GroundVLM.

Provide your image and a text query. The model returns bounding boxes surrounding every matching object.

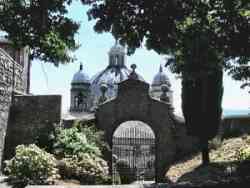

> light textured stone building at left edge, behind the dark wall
[0,37,30,163]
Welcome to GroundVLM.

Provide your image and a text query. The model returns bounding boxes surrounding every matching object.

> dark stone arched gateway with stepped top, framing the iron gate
[96,76,176,182]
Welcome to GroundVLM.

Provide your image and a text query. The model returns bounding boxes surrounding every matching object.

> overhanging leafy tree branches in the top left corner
[0,0,79,65]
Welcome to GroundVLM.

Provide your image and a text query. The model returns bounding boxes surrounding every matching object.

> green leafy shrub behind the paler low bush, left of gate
[54,127,101,157]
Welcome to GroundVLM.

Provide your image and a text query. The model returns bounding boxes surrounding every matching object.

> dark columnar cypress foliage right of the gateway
[182,67,223,140]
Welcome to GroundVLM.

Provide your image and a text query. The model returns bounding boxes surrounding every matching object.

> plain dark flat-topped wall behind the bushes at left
[4,95,61,162]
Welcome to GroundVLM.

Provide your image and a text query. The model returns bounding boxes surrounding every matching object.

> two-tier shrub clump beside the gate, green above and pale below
[54,123,110,184]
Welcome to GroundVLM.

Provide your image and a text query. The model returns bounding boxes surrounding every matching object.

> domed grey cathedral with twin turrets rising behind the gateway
[69,43,173,114]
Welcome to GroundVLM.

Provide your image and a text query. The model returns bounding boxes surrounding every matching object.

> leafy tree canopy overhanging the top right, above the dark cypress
[82,0,250,89]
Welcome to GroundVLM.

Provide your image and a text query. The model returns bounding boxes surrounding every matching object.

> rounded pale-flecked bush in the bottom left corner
[4,144,60,185]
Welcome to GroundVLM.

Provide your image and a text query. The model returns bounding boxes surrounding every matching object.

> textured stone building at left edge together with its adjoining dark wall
[0,37,61,169]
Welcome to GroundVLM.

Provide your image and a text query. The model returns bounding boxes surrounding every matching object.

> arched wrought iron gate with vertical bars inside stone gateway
[112,121,155,184]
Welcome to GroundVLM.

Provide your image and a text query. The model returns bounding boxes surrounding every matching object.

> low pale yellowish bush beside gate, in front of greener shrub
[59,153,109,184]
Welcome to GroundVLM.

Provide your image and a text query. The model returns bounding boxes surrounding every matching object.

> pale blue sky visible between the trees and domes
[31,1,250,114]
